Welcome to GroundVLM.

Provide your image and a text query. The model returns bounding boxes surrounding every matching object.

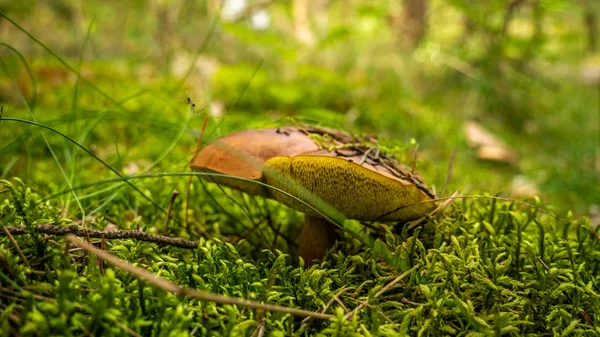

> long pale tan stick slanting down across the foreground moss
[66,235,336,319]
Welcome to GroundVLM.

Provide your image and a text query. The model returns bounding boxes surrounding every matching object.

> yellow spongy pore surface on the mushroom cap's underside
[262,155,435,221]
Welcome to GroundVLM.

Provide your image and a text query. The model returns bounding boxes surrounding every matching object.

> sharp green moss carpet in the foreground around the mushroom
[0,178,600,336]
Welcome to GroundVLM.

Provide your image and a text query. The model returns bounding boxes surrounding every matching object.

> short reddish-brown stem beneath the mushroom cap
[298,214,339,268]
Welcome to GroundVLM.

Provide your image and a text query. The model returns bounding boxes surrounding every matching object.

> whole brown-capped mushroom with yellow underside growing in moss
[190,127,435,266]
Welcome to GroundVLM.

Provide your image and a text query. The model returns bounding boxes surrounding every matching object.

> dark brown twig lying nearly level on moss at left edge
[0,224,198,249]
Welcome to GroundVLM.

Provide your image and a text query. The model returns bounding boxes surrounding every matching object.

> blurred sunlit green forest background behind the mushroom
[0,0,600,221]
